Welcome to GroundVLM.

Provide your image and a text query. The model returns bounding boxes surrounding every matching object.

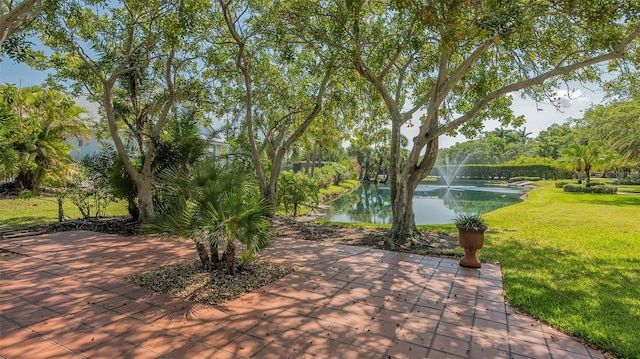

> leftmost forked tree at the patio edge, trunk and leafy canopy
[41,0,209,221]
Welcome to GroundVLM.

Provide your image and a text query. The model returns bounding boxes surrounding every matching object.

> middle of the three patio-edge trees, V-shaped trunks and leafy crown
[210,0,360,211]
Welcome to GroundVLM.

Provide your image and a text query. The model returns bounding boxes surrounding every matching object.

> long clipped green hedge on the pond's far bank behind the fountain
[431,164,572,180]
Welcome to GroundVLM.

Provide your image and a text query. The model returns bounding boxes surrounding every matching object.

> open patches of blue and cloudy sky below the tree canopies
[0,58,603,148]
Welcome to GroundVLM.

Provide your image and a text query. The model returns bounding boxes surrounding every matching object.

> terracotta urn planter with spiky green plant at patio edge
[454,212,487,268]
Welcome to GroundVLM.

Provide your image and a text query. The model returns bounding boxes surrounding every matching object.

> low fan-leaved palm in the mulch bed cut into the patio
[146,158,271,274]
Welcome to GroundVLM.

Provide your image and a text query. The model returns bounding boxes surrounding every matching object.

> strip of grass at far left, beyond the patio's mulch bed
[0,197,128,228]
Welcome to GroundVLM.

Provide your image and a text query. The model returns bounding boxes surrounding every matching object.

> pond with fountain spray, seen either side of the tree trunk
[318,184,525,224]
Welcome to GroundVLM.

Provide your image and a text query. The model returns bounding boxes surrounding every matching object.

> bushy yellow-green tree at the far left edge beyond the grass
[0,85,89,190]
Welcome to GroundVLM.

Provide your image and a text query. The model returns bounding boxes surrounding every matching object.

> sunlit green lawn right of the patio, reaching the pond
[478,182,640,358]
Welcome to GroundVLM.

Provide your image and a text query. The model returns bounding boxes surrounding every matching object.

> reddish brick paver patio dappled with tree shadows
[0,231,604,359]
